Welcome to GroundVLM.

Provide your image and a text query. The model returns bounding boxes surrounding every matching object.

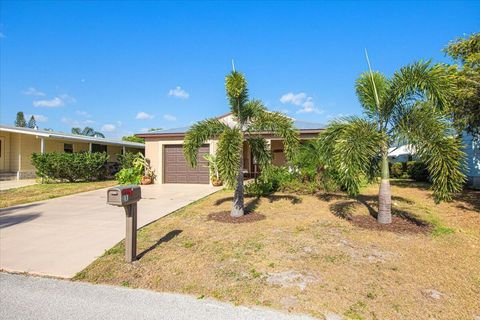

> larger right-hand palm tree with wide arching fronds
[319,57,465,224]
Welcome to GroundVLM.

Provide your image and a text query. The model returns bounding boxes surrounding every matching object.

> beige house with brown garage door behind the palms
[136,114,324,184]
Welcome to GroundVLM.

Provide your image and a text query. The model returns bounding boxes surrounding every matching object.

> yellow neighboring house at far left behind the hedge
[0,125,145,179]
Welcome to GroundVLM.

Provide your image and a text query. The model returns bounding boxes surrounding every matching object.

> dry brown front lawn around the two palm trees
[76,183,480,320]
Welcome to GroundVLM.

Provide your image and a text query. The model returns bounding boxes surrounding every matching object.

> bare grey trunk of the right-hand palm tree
[377,148,392,224]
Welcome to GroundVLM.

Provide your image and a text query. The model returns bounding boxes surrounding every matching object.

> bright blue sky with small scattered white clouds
[0,1,480,137]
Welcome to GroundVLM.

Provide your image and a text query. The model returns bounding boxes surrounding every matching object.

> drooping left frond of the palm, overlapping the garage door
[183,119,228,168]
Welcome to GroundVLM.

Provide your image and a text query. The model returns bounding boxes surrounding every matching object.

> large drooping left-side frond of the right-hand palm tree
[319,117,385,195]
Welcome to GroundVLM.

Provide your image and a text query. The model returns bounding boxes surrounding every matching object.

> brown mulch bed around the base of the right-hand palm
[347,215,432,234]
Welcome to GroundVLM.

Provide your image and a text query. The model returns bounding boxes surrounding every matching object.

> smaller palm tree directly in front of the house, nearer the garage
[183,70,298,217]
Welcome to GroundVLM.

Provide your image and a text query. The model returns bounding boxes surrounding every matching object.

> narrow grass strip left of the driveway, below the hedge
[0,180,117,208]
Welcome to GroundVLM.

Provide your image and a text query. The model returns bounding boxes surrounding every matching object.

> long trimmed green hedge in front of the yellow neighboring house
[31,152,108,182]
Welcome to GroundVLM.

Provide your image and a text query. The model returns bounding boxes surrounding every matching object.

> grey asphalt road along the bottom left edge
[0,273,312,320]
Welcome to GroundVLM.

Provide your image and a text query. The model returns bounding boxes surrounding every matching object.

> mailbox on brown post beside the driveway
[107,185,142,262]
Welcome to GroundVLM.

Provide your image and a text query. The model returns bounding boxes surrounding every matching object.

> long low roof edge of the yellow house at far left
[0,124,145,149]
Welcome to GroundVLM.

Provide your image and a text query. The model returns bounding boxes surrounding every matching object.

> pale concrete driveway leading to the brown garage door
[0,184,218,278]
